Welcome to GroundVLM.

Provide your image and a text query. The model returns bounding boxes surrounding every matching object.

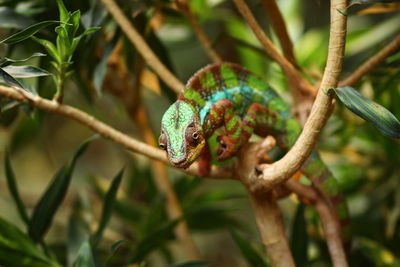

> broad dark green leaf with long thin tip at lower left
[28,140,90,242]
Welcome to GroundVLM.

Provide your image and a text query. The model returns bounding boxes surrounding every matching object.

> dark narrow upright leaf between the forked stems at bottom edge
[290,203,308,266]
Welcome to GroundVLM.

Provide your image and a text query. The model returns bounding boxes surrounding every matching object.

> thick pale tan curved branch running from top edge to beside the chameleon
[253,0,347,193]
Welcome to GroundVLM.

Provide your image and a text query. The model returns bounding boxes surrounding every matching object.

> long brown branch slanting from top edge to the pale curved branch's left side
[233,0,315,103]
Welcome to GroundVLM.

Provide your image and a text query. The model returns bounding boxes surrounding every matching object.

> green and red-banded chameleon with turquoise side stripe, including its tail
[159,63,350,243]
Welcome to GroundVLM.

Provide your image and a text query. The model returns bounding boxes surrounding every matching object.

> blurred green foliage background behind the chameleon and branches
[0,0,400,266]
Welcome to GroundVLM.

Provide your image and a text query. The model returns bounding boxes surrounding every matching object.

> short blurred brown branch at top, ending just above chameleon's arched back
[175,0,222,63]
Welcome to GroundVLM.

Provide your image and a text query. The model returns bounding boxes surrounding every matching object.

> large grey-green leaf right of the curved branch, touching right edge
[328,86,400,138]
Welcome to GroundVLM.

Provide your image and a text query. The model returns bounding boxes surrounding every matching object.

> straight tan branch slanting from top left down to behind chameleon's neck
[101,0,184,93]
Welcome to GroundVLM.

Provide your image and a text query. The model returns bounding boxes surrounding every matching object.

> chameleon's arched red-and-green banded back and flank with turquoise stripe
[179,63,290,125]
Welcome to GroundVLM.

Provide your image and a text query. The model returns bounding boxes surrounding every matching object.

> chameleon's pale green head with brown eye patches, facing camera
[158,100,206,169]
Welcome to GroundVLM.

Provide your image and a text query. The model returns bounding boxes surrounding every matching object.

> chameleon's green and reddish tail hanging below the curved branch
[301,151,351,247]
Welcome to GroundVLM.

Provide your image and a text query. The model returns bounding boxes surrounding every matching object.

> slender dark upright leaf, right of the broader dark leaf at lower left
[92,169,124,247]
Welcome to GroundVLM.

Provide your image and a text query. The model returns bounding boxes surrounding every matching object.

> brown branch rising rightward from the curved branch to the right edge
[339,35,400,86]
